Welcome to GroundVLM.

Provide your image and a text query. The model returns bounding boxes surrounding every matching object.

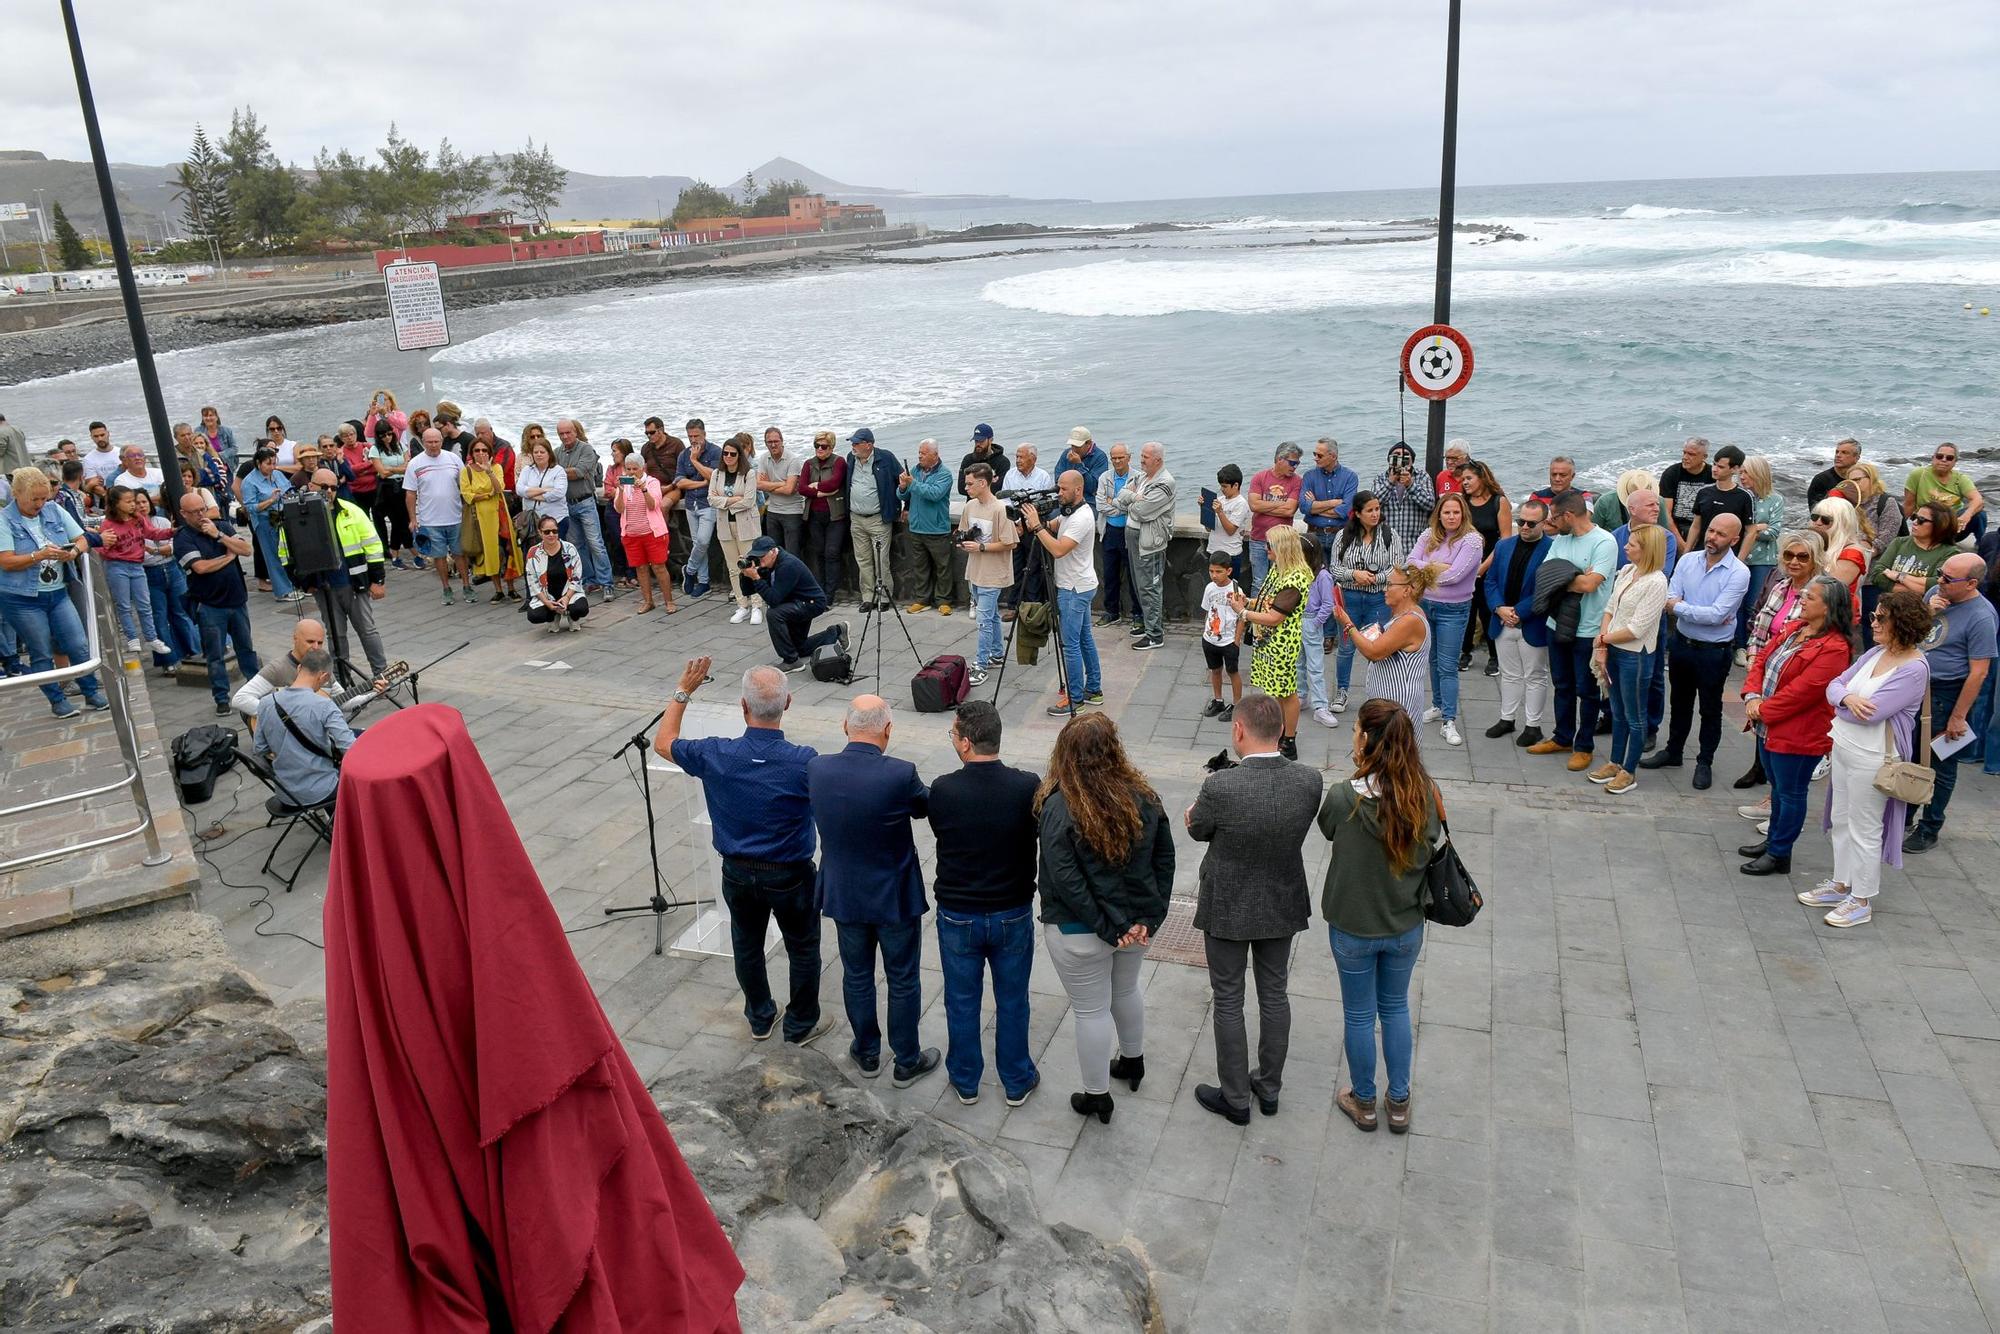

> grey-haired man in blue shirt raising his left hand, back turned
[652,658,834,1046]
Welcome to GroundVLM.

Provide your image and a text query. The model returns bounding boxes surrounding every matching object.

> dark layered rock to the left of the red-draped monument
[0,912,332,1334]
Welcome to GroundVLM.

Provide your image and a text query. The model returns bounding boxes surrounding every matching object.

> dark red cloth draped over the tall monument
[326,704,742,1334]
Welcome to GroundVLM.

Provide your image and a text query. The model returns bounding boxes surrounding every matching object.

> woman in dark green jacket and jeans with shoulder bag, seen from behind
[1320,698,1442,1134]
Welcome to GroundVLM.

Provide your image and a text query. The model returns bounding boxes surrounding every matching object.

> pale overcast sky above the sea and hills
[0,0,2000,200]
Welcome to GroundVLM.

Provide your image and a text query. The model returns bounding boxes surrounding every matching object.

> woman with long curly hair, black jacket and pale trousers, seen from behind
[1034,714,1174,1124]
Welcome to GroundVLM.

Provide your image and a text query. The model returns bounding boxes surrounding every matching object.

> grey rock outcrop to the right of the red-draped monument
[660,1052,1164,1334]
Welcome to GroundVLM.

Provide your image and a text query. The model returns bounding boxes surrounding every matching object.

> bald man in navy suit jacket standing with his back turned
[806,694,938,1088]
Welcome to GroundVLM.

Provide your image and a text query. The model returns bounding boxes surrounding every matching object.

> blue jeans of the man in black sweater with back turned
[938,904,1036,1098]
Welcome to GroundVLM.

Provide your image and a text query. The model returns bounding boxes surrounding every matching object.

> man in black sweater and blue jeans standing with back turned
[930,700,1042,1108]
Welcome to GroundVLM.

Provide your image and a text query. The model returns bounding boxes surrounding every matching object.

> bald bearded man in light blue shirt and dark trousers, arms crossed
[1638,514,1750,792]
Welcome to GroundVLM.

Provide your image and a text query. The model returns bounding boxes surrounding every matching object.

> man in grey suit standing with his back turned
[1186,690,1320,1126]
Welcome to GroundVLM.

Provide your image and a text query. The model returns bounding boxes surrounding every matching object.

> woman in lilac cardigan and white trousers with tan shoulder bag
[1798,588,1930,926]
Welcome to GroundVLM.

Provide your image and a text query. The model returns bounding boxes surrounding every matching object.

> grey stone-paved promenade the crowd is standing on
[152,574,2000,1334]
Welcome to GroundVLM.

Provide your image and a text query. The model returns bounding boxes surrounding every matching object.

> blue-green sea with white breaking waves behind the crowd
[0,172,2000,494]
